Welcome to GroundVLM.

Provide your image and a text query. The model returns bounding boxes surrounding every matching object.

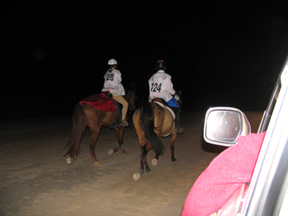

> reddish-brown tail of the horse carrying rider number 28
[64,104,87,159]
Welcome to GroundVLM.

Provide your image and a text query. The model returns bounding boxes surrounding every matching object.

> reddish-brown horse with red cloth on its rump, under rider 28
[64,91,136,165]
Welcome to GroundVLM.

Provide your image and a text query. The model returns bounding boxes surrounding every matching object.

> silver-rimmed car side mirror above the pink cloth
[203,107,251,147]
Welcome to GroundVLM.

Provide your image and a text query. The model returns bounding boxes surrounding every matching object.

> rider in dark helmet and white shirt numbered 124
[148,60,184,134]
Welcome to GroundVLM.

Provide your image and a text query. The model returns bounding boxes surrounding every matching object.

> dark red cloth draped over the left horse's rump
[79,93,116,112]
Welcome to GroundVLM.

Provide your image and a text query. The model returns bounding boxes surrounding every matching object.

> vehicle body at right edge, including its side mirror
[203,54,288,216]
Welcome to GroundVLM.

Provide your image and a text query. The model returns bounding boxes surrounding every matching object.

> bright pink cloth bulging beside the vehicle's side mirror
[182,132,266,216]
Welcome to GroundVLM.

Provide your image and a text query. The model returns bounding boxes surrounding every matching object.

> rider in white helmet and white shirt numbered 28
[102,59,128,127]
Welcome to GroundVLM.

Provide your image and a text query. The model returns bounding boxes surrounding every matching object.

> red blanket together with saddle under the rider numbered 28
[79,92,122,114]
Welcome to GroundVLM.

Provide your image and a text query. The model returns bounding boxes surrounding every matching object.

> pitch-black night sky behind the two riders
[0,0,288,119]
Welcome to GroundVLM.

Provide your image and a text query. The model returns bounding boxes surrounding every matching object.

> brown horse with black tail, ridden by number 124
[133,91,182,181]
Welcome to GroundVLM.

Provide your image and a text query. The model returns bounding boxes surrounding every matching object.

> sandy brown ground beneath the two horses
[0,111,260,216]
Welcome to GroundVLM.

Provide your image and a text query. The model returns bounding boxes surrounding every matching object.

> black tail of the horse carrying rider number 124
[140,102,164,155]
